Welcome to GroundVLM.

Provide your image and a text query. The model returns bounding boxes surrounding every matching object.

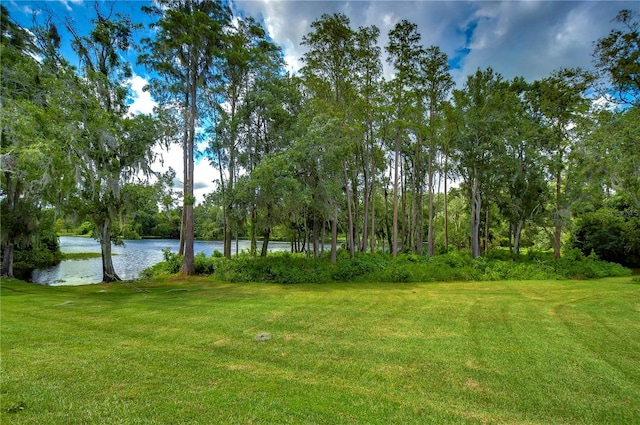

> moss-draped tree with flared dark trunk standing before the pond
[59,3,158,282]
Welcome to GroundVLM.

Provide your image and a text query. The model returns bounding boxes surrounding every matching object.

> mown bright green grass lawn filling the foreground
[0,277,640,424]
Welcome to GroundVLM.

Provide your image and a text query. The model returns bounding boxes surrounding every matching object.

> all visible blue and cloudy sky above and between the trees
[2,0,640,200]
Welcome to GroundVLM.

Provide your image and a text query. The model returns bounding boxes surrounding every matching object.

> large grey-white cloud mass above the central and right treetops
[234,0,635,87]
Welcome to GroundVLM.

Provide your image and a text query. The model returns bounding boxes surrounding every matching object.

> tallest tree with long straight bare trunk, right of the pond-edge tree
[139,0,231,275]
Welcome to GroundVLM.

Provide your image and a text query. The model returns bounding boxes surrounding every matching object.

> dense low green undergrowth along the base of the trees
[143,249,631,283]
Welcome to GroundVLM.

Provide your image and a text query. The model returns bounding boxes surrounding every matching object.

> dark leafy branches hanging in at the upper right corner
[593,9,640,105]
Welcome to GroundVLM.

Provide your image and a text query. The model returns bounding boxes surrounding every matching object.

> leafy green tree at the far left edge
[0,5,68,277]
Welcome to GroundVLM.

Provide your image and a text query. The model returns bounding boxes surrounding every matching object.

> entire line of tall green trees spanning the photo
[0,0,640,282]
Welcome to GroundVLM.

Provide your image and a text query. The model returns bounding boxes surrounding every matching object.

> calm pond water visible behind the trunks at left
[30,236,291,286]
